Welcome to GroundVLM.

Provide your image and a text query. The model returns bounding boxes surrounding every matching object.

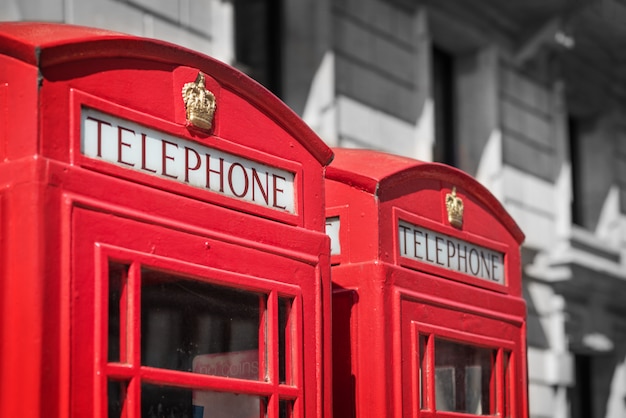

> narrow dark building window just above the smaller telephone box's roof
[432,46,457,166]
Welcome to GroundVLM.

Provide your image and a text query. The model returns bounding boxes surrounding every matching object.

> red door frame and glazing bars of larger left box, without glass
[71,207,308,417]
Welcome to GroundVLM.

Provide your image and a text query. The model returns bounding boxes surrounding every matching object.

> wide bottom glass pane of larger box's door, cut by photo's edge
[141,384,264,418]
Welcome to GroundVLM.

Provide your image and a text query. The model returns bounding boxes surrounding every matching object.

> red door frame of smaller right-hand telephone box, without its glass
[394,284,526,418]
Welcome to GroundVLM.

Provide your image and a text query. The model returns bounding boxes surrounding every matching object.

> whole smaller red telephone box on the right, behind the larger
[326,149,528,418]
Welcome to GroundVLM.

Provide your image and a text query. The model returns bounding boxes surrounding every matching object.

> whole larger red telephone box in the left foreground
[0,23,332,418]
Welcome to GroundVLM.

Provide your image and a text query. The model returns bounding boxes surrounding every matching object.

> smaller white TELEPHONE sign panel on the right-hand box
[398,220,504,285]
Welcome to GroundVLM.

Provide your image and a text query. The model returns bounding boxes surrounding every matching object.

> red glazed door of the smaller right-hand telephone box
[396,282,525,417]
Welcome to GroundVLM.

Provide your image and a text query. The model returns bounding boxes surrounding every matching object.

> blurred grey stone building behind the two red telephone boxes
[0,0,626,418]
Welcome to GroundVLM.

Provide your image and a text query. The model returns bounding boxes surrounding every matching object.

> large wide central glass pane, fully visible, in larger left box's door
[141,269,266,380]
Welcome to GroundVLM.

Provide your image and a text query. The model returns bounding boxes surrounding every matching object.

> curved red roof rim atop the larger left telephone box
[0,22,333,165]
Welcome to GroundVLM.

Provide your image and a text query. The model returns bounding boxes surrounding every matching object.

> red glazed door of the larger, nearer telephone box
[71,208,314,418]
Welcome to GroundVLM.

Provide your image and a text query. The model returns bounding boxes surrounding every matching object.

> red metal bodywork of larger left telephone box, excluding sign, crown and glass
[0,22,332,418]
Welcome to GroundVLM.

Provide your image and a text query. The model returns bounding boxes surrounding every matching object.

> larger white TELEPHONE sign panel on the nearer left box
[81,108,296,213]
